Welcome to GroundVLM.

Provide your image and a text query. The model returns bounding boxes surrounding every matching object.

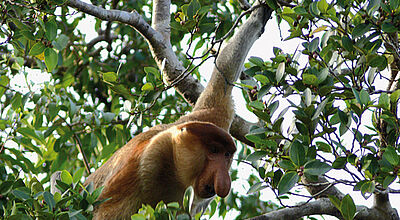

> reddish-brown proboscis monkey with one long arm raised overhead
[74,1,272,219]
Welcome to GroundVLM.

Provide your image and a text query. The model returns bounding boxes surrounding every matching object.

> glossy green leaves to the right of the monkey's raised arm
[242,0,400,219]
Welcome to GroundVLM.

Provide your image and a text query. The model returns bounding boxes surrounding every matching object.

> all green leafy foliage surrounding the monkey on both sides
[0,0,400,219]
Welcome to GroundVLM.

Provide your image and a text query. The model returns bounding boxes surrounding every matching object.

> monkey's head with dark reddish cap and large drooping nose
[173,122,236,199]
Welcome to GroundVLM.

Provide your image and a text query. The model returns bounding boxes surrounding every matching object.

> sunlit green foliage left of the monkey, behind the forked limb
[0,0,268,219]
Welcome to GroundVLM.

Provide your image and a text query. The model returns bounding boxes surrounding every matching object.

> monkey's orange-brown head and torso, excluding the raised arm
[85,121,236,219]
